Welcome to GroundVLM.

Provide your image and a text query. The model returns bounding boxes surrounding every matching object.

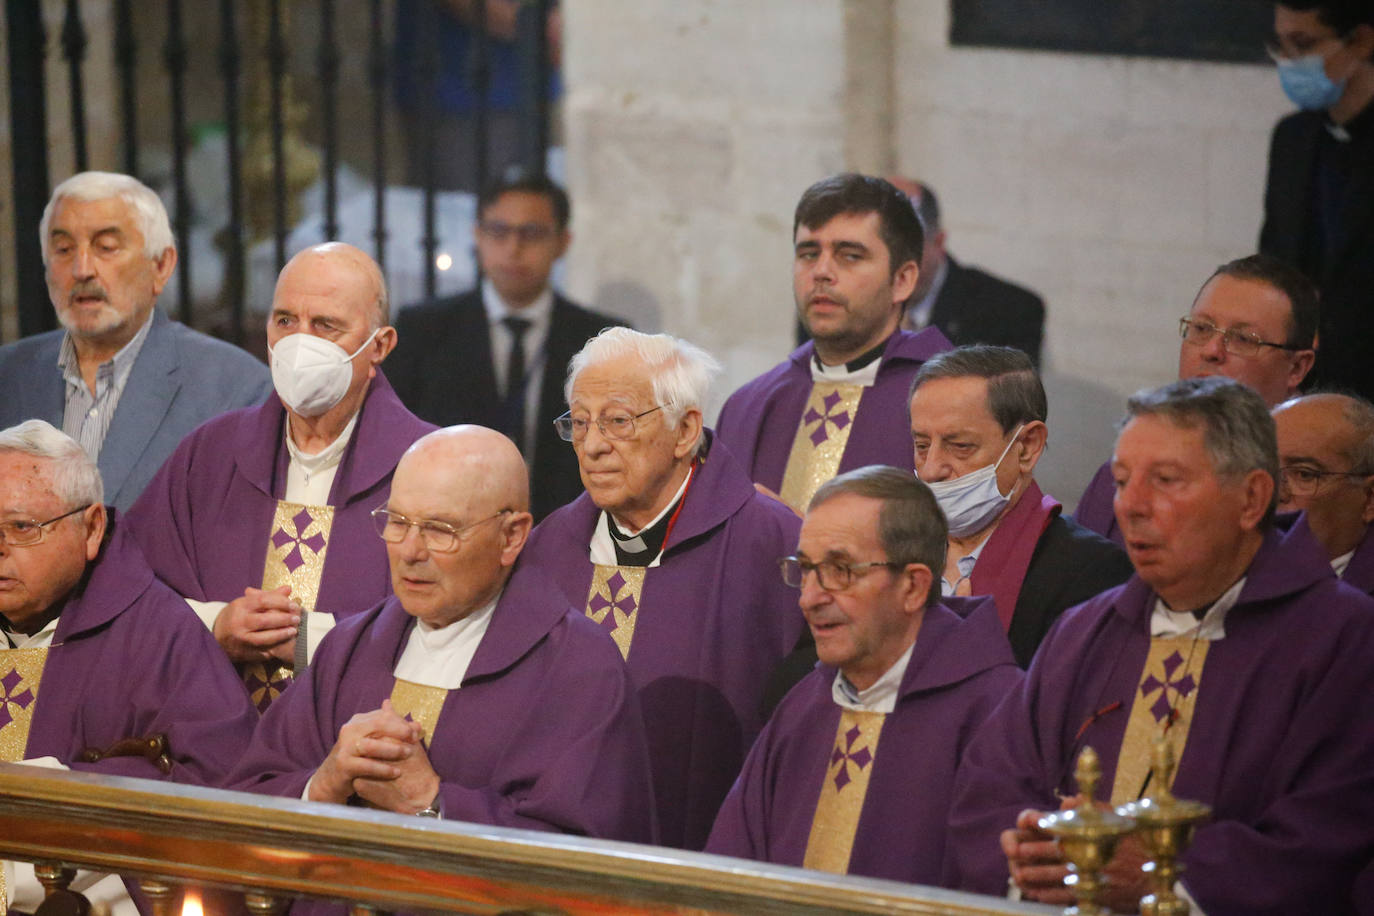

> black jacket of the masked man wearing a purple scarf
[1007,515,1135,667]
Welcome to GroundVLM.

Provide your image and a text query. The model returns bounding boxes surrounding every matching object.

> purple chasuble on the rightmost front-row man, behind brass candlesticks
[947,521,1374,916]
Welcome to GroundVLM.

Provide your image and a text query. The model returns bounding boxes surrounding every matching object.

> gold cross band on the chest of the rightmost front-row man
[1112,636,1210,805]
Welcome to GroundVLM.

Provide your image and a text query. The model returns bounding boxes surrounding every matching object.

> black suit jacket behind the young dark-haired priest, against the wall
[930,257,1044,367]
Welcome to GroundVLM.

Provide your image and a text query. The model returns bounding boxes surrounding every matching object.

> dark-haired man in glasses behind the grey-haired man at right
[1073,254,1318,547]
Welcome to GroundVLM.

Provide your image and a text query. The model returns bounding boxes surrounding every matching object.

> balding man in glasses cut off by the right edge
[1274,394,1374,595]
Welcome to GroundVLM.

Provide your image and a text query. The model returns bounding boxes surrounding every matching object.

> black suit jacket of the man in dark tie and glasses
[386,290,624,522]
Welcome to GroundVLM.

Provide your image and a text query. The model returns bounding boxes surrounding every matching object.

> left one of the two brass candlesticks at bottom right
[1040,747,1135,916]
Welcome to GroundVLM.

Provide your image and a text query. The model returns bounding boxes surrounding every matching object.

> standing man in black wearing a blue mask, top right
[1260,0,1374,398]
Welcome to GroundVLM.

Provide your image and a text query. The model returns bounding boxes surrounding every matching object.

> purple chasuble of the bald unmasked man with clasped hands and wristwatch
[231,560,655,851]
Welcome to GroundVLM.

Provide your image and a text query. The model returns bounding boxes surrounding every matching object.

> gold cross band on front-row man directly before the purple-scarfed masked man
[801,709,888,875]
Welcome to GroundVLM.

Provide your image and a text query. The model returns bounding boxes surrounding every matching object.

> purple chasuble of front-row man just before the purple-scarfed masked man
[706,597,1022,884]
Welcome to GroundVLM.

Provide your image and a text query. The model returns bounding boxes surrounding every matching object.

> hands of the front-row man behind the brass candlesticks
[1000,797,1151,913]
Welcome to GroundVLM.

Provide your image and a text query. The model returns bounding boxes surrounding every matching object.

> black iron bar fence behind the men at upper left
[5,0,558,343]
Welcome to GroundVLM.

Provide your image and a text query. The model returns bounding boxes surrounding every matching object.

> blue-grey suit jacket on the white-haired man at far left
[0,312,272,511]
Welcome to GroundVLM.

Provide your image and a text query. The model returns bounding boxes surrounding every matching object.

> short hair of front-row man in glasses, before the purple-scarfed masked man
[807,464,949,607]
